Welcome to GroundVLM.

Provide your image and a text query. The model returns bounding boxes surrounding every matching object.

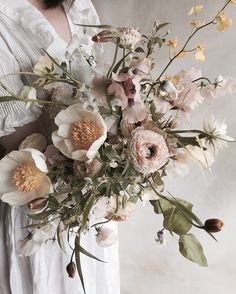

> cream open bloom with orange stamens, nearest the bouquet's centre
[52,104,107,161]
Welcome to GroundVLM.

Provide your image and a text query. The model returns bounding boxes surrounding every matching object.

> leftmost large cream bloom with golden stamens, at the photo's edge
[0,148,53,206]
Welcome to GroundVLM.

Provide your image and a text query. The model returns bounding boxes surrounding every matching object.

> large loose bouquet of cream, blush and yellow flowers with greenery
[0,0,236,285]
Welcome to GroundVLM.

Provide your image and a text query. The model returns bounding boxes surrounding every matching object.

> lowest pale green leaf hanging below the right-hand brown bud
[179,234,208,267]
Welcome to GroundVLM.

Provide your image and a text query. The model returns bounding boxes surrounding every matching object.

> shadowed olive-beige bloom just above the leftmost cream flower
[19,133,47,152]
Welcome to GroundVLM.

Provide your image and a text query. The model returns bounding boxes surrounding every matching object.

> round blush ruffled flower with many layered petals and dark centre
[128,128,169,174]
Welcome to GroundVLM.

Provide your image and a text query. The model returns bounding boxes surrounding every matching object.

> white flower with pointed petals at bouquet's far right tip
[203,115,234,152]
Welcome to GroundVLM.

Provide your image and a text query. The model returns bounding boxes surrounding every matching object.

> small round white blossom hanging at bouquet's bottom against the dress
[96,226,118,247]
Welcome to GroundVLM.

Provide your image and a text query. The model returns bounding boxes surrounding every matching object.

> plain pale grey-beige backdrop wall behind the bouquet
[93,0,236,294]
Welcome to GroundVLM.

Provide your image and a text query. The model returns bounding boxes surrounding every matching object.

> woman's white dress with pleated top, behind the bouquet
[0,0,120,294]
